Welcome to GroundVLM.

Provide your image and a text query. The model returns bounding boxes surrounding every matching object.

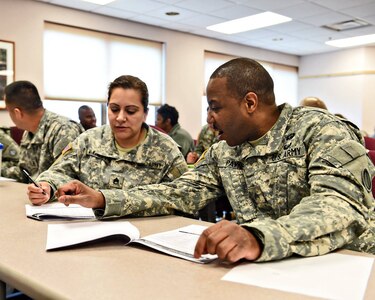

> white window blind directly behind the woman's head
[44,23,163,104]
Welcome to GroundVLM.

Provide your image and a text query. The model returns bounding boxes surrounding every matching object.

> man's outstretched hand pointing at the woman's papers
[56,180,105,208]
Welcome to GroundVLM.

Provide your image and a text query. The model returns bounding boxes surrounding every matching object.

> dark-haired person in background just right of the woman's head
[155,104,194,158]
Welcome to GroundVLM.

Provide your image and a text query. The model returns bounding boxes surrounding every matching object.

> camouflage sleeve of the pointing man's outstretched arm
[95,148,224,219]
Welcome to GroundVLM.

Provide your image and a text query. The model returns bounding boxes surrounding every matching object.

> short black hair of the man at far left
[4,80,43,112]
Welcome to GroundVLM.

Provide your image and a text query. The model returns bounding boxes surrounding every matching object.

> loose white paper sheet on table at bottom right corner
[222,253,374,300]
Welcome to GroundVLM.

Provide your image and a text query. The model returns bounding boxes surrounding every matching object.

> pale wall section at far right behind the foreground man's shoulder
[298,46,375,134]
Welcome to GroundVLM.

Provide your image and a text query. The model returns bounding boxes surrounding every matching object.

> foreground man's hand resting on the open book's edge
[194,220,261,263]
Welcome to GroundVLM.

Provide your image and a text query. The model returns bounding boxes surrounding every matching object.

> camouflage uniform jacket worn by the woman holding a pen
[37,124,187,196]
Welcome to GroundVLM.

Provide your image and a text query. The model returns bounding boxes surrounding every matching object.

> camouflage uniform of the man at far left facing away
[2,110,82,183]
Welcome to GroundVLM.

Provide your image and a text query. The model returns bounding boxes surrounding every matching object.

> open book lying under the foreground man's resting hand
[46,221,217,263]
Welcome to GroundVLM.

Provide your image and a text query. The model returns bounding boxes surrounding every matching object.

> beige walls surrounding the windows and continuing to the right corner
[0,0,375,137]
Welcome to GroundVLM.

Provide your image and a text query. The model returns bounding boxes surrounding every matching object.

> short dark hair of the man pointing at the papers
[210,57,275,104]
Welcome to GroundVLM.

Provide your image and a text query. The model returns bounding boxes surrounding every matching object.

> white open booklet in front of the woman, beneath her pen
[25,202,95,221]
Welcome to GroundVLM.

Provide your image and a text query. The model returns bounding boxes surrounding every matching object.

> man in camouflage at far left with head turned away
[1,81,82,182]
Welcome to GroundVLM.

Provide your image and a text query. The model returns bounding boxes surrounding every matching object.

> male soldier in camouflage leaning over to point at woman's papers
[53,58,375,262]
